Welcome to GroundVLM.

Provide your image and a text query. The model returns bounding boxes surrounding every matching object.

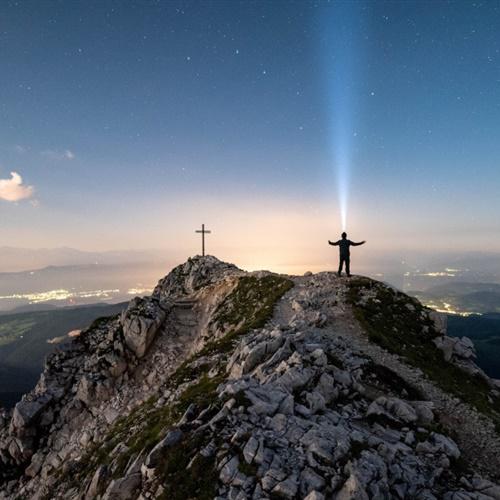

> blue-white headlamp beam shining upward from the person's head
[321,2,367,231]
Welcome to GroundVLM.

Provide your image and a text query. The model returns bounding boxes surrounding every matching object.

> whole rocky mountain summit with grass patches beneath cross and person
[0,256,500,500]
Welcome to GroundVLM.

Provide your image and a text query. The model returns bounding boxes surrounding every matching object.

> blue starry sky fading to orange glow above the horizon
[0,0,500,270]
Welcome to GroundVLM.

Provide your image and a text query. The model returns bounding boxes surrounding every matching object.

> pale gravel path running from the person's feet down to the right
[273,273,500,480]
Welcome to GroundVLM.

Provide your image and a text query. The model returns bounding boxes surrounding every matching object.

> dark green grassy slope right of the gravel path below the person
[348,278,500,426]
